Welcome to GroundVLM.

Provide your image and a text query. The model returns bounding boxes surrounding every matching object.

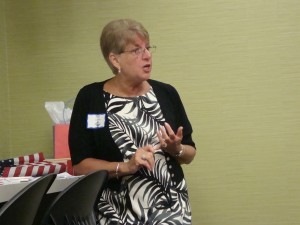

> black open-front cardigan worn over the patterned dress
[69,80,195,188]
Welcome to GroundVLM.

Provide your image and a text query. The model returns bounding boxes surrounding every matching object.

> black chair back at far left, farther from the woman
[0,174,56,225]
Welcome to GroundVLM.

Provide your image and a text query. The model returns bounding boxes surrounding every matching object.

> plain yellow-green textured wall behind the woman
[0,0,300,225]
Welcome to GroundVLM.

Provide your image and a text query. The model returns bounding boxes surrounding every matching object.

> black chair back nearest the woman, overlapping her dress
[42,170,108,225]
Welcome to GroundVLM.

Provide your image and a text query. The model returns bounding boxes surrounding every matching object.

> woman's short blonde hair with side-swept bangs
[100,19,149,74]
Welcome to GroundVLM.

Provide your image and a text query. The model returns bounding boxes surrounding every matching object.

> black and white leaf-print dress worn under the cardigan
[98,89,191,225]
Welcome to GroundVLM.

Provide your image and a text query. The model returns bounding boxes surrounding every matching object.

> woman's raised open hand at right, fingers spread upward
[157,123,183,156]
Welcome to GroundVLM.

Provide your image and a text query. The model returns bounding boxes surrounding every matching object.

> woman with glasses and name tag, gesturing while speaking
[69,19,196,225]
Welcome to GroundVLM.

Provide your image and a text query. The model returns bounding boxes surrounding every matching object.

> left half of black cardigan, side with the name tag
[69,81,123,165]
